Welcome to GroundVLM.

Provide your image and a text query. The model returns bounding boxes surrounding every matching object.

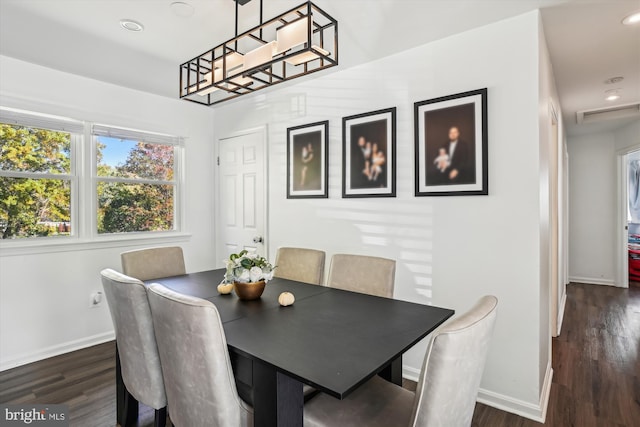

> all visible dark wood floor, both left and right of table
[0,284,640,427]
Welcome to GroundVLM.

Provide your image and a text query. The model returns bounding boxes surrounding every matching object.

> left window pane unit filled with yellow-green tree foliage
[0,109,84,239]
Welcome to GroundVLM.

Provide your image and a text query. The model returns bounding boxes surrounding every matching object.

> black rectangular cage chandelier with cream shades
[180,0,338,105]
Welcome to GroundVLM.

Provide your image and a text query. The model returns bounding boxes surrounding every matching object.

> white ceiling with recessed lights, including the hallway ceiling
[0,0,640,134]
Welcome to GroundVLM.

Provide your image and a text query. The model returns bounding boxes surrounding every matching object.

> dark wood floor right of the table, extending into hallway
[473,284,640,427]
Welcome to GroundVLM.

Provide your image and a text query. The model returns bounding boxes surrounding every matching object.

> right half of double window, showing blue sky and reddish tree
[92,125,181,234]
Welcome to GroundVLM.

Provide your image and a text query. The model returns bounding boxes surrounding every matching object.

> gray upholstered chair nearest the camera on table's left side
[148,283,253,427]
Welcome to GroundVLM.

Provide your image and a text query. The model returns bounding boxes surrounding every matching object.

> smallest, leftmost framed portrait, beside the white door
[287,121,329,199]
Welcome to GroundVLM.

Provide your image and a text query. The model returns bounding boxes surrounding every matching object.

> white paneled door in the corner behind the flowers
[216,129,267,259]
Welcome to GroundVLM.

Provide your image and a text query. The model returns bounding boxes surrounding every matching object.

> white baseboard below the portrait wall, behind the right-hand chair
[402,361,553,423]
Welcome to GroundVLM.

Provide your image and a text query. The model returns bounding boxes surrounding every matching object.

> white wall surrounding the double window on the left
[0,56,215,369]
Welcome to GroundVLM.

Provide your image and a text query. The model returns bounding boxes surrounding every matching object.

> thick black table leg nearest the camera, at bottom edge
[253,361,304,427]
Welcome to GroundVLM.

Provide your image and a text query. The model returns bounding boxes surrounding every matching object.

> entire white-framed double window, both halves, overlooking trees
[0,107,183,246]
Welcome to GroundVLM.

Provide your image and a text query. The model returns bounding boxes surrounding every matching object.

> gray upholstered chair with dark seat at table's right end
[304,296,498,427]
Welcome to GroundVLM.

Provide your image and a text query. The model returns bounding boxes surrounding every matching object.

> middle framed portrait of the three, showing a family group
[342,107,396,198]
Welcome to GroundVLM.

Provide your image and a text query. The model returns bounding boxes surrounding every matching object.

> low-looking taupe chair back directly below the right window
[120,246,187,281]
